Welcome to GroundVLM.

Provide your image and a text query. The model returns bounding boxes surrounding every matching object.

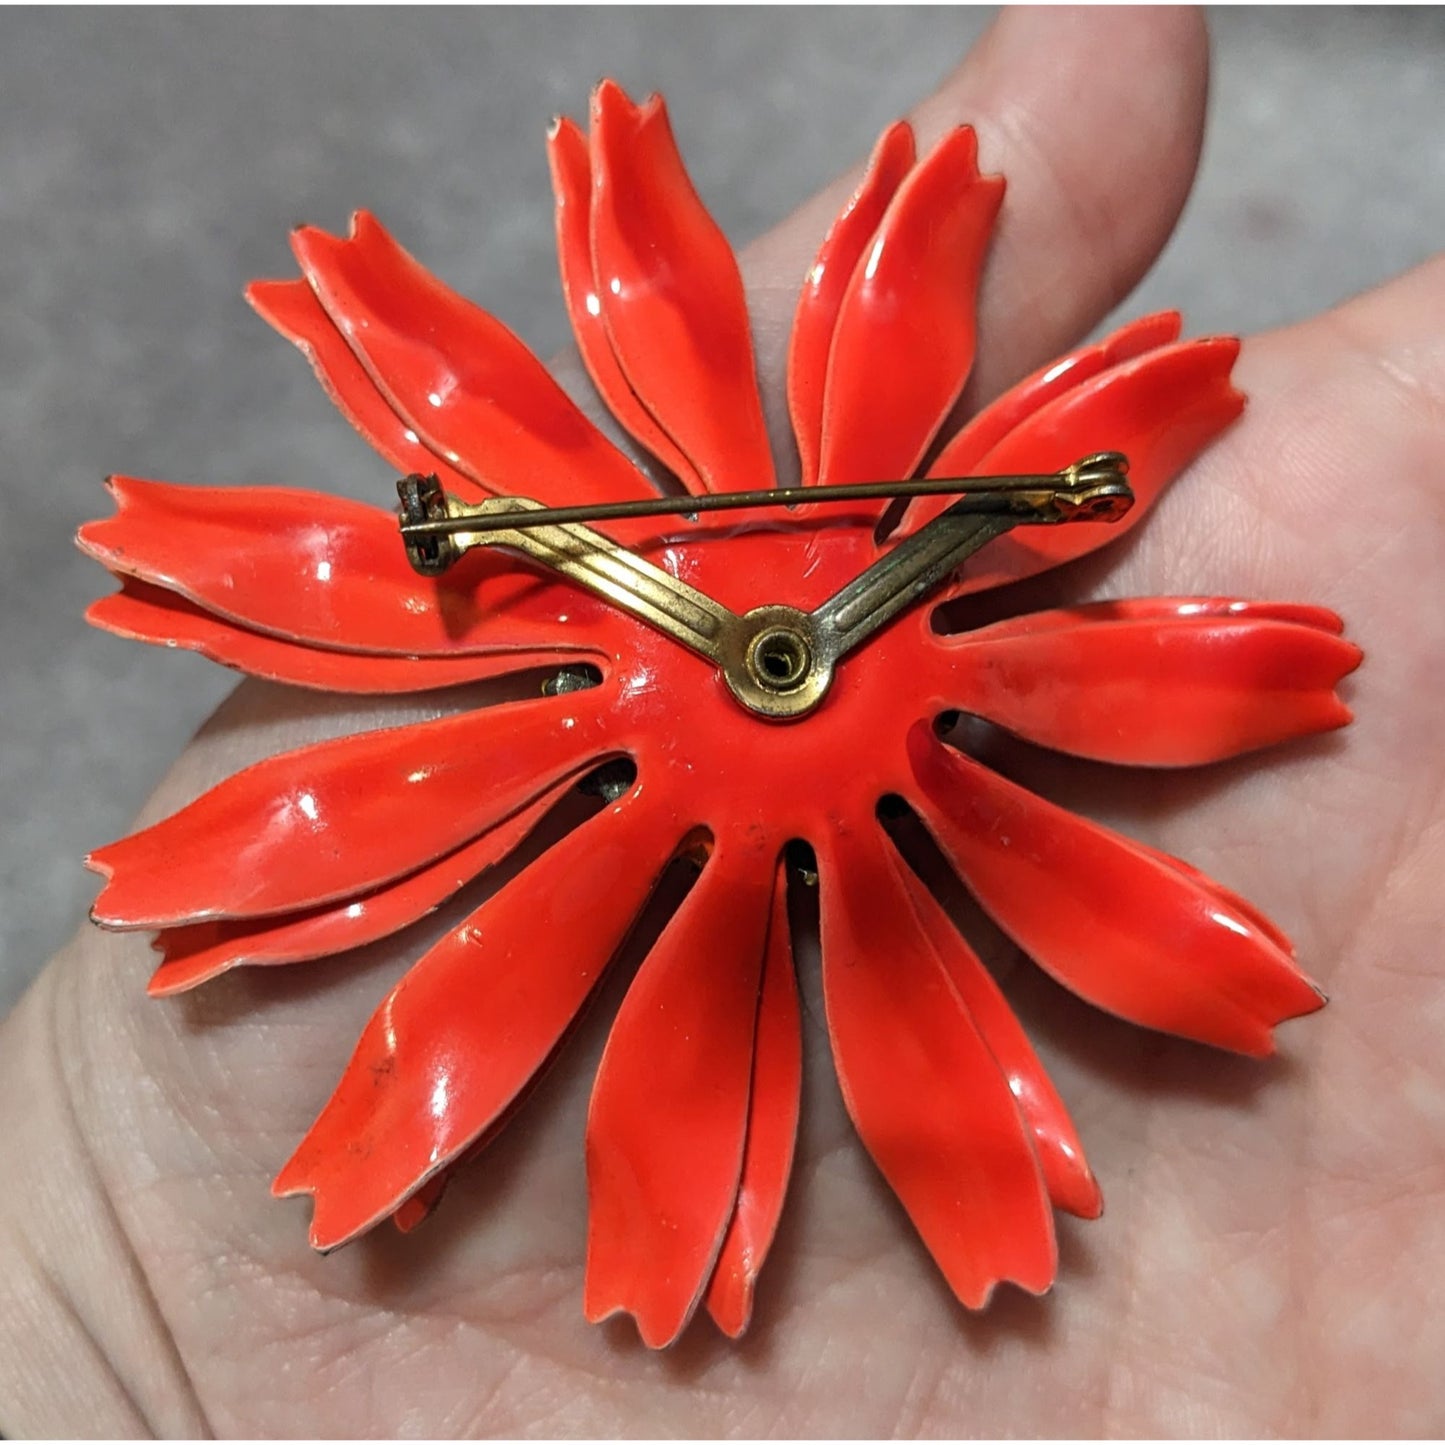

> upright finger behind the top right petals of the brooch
[741,6,1208,405]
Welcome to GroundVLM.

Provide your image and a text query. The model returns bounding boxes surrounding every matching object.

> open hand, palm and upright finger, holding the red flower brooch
[0,10,1445,1436]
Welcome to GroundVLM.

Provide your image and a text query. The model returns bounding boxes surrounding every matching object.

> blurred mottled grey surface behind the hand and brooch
[8,9,1445,1012]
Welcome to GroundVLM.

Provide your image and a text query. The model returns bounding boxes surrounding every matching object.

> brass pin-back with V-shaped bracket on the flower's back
[397,452,1134,720]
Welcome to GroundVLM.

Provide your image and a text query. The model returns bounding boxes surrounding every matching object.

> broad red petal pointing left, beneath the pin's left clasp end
[78,477,617,656]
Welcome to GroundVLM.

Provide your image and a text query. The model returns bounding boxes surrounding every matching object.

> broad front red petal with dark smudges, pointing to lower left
[272,795,678,1250]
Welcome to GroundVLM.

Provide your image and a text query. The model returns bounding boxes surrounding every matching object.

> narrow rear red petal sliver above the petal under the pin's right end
[924,311,1182,488]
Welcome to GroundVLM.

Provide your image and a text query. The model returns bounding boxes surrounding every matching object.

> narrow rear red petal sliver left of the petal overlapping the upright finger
[788,120,915,486]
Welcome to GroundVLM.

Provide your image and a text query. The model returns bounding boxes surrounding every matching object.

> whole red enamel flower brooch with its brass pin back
[81,84,1360,1345]
